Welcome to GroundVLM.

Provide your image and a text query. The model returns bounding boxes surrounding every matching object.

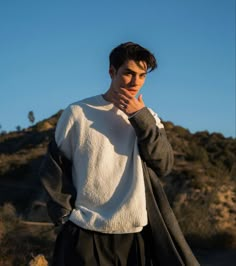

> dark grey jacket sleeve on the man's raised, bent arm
[129,107,174,177]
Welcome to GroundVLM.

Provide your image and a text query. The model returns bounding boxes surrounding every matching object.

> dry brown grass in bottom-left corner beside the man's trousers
[0,203,55,266]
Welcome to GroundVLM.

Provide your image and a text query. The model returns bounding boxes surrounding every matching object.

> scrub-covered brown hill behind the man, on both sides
[0,108,236,247]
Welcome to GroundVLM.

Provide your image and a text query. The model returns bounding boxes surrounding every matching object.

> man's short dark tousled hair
[109,42,157,72]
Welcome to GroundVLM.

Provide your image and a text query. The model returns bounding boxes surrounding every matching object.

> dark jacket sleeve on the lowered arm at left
[39,140,76,225]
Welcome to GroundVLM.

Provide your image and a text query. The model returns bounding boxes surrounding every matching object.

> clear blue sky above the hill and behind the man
[0,0,236,137]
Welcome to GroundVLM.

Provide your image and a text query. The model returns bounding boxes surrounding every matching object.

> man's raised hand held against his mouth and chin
[111,88,145,116]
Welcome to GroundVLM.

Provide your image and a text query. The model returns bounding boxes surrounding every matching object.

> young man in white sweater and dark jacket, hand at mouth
[41,42,199,266]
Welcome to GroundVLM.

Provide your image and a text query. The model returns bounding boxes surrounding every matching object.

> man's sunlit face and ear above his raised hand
[109,60,147,96]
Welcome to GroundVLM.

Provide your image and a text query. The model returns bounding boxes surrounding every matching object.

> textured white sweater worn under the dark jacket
[55,95,147,233]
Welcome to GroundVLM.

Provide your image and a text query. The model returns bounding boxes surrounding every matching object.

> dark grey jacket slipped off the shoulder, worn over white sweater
[40,108,199,266]
